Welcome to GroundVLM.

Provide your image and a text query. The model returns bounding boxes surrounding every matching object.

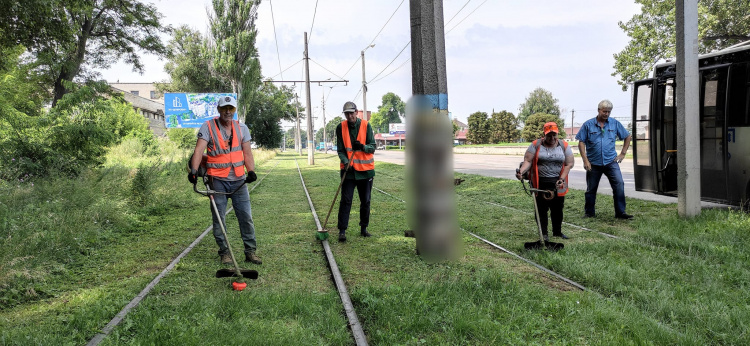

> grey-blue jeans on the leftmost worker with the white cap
[211,179,256,255]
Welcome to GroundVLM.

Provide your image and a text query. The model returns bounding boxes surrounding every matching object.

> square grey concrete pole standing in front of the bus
[675,0,701,217]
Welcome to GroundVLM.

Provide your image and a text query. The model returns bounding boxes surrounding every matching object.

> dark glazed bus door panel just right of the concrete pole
[699,66,728,200]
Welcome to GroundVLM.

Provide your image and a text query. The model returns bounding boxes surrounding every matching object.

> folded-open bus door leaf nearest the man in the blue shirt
[631,79,657,192]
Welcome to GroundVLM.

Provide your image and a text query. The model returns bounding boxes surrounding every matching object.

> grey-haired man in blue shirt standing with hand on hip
[576,100,633,220]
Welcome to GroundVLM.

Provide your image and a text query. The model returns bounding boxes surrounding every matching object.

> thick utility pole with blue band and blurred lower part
[406,0,459,261]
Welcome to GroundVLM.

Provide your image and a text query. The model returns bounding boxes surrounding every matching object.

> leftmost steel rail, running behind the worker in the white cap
[86,162,279,346]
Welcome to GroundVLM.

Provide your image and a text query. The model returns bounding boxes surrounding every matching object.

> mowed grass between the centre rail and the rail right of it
[294,156,689,344]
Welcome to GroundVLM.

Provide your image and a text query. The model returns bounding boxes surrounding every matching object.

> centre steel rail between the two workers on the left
[294,158,367,346]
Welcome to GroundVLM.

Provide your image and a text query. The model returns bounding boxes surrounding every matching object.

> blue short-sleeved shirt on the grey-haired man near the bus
[576,118,630,166]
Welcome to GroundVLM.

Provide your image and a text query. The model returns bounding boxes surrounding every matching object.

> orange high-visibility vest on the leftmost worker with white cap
[206,117,245,178]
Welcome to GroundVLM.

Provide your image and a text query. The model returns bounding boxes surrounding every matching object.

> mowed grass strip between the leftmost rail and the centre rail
[100,156,353,345]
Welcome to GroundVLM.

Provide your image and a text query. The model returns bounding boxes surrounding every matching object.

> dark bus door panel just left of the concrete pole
[653,76,677,196]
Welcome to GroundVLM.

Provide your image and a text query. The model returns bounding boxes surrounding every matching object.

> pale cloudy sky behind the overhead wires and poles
[100,0,640,129]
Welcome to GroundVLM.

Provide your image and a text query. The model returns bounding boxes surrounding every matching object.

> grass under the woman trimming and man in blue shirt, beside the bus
[374,162,750,344]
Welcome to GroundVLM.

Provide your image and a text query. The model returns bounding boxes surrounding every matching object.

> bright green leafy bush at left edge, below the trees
[0,83,157,180]
